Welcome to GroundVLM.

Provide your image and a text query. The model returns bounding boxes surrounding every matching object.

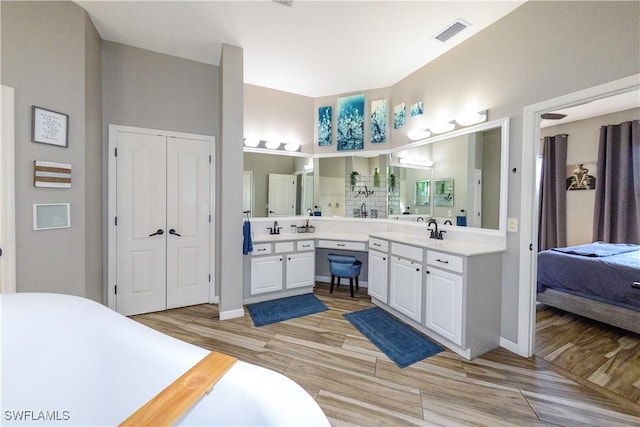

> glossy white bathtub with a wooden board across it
[0,293,329,426]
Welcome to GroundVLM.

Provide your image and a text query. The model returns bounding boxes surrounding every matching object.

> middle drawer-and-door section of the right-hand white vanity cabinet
[389,242,423,322]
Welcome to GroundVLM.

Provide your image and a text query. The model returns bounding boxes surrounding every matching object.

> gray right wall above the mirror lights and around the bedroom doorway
[392,1,640,342]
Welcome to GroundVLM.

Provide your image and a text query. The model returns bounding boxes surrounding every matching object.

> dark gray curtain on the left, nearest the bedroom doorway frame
[538,134,569,251]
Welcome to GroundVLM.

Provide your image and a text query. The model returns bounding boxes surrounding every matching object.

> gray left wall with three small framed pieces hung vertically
[1,1,102,301]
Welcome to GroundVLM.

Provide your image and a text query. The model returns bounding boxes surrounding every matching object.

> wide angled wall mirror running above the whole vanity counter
[244,119,509,233]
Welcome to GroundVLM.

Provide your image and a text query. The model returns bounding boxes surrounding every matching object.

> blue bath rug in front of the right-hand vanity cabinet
[343,307,443,368]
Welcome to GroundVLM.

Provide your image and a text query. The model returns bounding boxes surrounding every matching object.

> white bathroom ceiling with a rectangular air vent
[76,0,524,97]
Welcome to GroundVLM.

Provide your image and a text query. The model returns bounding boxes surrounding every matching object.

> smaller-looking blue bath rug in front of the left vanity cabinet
[247,294,329,326]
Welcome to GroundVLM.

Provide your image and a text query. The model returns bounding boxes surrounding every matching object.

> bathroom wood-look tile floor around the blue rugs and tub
[132,284,640,426]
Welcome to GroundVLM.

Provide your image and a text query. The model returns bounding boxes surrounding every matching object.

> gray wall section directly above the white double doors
[102,41,220,137]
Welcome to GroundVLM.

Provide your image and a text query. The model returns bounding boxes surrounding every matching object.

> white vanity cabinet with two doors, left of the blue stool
[243,240,315,303]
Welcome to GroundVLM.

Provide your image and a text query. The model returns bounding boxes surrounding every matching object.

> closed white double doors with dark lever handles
[115,132,211,315]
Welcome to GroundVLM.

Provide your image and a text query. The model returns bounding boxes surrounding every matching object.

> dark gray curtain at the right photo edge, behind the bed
[593,120,640,243]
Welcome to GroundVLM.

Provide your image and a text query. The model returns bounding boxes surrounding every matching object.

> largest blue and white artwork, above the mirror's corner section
[337,95,364,151]
